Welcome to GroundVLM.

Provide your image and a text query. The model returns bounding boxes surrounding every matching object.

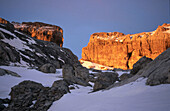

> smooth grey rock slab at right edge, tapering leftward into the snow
[107,48,170,89]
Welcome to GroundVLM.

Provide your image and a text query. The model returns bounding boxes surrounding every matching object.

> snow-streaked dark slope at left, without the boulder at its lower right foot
[0,19,75,68]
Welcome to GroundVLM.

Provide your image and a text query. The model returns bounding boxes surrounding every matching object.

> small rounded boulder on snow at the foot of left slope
[39,63,56,73]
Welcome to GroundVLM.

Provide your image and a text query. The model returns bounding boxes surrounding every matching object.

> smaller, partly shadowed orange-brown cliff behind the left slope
[13,22,64,47]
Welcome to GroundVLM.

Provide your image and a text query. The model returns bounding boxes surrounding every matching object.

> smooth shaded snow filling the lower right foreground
[48,78,170,111]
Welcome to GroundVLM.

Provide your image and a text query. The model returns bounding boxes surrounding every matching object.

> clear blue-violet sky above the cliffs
[0,0,170,59]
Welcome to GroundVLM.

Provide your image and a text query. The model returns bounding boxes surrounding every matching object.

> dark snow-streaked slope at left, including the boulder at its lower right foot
[0,19,89,86]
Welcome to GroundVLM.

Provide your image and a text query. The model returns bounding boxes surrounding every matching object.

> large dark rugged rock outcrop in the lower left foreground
[4,80,69,111]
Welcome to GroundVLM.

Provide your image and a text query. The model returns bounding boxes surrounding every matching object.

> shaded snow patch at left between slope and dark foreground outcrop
[0,66,62,98]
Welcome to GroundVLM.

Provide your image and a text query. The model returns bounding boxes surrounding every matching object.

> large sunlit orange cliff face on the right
[81,24,170,69]
